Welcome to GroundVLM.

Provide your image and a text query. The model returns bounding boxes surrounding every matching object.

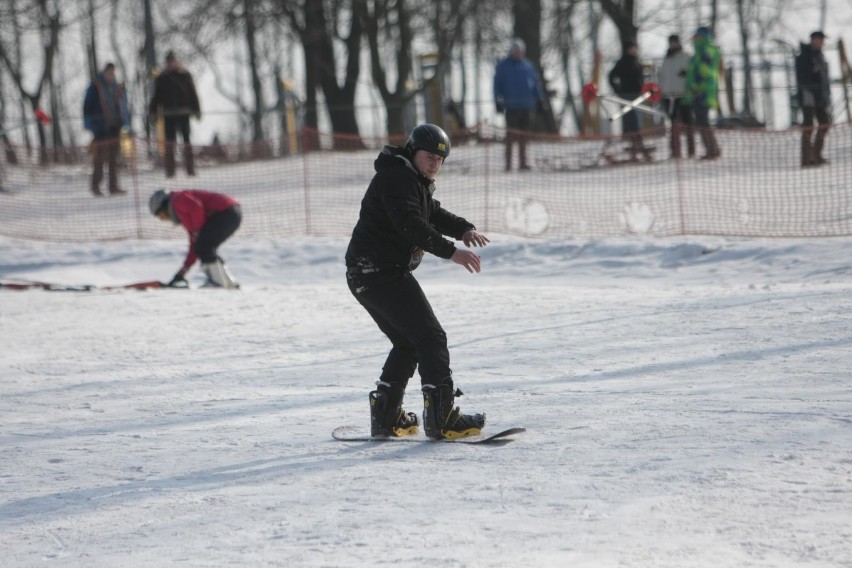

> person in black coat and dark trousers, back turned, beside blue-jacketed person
[148,51,201,177]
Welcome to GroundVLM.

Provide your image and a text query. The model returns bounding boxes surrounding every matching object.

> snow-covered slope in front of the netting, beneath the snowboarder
[0,235,852,568]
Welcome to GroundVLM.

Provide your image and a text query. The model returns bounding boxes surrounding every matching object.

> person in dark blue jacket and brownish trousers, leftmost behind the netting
[83,63,130,196]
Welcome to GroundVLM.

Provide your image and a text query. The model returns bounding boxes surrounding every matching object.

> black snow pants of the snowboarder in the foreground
[346,270,452,388]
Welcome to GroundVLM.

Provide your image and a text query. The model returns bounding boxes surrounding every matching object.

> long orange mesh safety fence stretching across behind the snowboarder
[0,124,852,242]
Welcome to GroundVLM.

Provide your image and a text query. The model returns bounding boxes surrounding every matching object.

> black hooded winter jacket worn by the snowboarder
[346,146,475,274]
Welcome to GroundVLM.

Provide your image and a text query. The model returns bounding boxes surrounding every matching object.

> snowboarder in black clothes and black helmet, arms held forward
[346,124,489,439]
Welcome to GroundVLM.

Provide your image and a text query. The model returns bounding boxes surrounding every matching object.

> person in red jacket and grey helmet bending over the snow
[148,189,242,288]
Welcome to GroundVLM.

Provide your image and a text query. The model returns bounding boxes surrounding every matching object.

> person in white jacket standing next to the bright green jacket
[660,35,695,159]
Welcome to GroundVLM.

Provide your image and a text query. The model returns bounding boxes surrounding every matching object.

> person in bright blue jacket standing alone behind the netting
[494,38,544,172]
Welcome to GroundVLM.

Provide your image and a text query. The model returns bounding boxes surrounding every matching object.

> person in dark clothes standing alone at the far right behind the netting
[796,31,831,168]
